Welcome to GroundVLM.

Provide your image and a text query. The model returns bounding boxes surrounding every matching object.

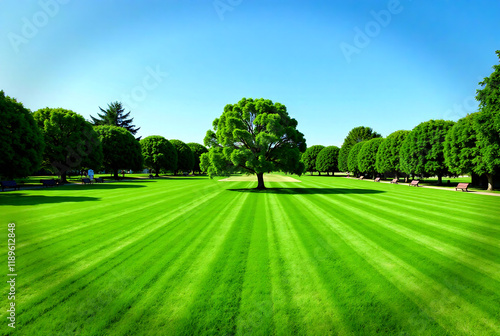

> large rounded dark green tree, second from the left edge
[33,107,103,183]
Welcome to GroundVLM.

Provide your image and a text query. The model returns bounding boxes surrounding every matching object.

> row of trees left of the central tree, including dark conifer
[0,95,207,181]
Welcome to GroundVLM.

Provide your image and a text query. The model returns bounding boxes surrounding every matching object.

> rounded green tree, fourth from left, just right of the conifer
[139,135,177,176]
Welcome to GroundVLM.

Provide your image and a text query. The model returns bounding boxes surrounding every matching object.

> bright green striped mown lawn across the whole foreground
[0,176,500,335]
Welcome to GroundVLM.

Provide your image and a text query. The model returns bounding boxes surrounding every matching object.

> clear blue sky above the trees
[0,0,500,146]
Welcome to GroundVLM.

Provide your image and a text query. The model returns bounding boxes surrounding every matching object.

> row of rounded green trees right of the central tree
[302,51,500,190]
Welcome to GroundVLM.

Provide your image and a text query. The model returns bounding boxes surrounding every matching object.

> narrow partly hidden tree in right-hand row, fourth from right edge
[375,131,410,177]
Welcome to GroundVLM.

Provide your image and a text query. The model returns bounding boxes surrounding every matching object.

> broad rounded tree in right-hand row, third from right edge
[400,120,454,184]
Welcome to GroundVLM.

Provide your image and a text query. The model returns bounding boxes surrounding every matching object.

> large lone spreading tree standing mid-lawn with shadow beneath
[201,98,306,189]
